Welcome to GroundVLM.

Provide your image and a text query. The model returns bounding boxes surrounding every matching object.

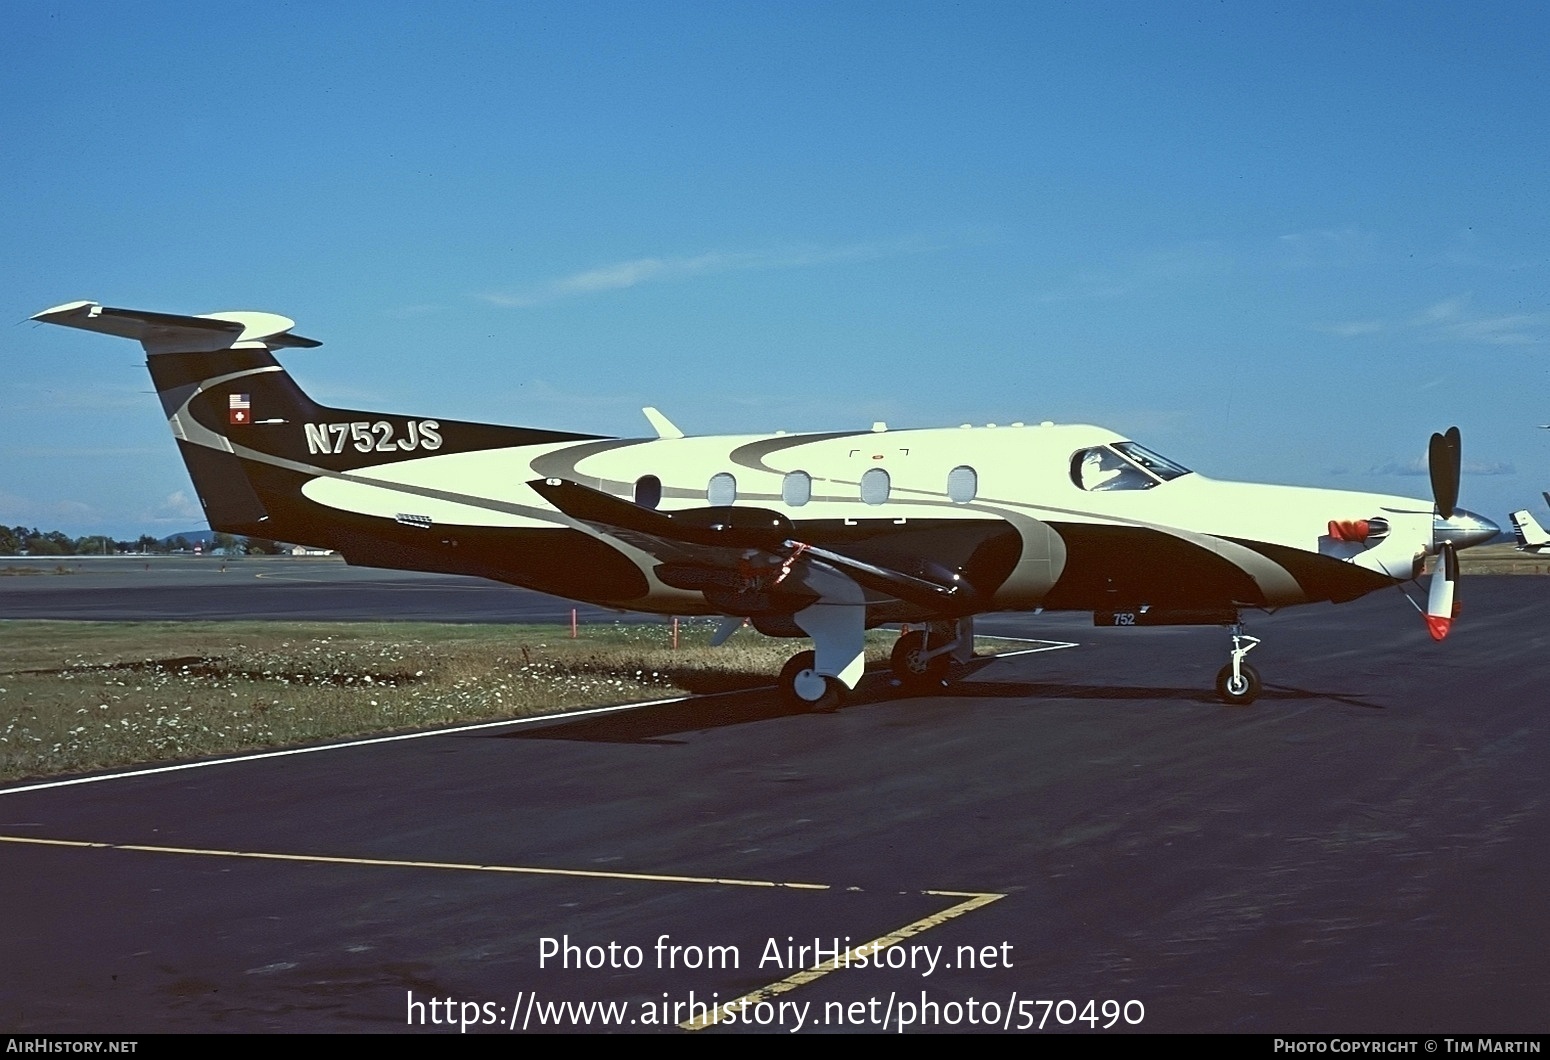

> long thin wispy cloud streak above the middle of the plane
[481,239,942,308]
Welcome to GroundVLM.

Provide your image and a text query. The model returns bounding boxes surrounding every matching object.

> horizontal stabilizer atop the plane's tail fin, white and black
[33,302,322,353]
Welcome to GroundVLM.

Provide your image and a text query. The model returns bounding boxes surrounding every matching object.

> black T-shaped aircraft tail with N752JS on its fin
[33,302,592,545]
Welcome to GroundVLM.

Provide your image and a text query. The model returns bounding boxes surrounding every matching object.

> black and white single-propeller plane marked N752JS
[33,302,1497,710]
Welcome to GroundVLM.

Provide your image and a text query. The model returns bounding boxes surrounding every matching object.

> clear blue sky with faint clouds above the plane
[0,2,1550,536]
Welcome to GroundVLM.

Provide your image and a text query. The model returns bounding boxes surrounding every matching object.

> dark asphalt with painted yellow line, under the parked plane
[0,572,1550,1034]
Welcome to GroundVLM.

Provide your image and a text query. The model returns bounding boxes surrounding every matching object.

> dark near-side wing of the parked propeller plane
[529,479,980,615]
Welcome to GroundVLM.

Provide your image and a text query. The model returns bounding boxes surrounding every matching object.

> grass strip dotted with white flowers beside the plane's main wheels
[0,621,893,781]
